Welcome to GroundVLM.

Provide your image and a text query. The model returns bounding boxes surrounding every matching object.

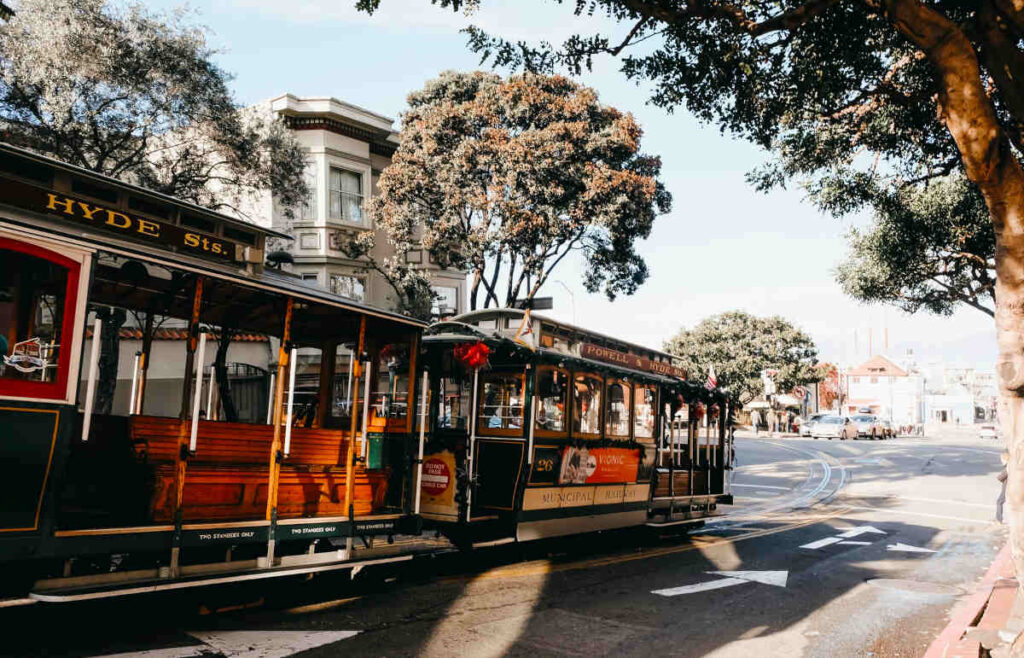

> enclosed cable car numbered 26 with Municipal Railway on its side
[419,309,732,546]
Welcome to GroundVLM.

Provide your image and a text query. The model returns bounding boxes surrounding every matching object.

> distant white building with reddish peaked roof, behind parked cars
[843,354,925,425]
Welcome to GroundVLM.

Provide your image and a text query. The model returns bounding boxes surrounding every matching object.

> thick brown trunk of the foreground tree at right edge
[886,0,1024,582]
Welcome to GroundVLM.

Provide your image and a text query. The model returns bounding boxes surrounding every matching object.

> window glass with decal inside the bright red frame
[0,247,70,395]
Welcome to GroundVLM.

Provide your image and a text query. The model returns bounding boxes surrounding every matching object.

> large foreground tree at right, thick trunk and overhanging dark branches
[356,0,1024,593]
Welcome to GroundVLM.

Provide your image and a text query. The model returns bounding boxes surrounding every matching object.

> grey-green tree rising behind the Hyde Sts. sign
[0,0,307,221]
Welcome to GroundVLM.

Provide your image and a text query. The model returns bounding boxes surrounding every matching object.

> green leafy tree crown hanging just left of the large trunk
[837,176,995,315]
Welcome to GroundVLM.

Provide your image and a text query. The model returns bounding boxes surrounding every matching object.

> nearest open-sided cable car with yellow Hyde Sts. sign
[0,145,425,602]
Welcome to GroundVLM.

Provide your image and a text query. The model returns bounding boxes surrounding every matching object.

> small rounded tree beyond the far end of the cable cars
[665,311,822,404]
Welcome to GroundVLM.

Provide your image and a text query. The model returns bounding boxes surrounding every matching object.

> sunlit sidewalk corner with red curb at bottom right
[925,543,1024,658]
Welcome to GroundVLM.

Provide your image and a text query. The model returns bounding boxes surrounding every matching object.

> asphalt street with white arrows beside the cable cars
[0,434,1006,658]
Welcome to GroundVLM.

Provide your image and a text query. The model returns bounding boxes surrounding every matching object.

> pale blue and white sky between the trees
[145,0,995,369]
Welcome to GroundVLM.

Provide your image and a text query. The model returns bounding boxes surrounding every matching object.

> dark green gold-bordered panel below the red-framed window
[0,406,60,530]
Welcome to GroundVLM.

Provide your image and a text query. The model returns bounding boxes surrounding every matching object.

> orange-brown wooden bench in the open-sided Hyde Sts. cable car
[124,415,389,523]
